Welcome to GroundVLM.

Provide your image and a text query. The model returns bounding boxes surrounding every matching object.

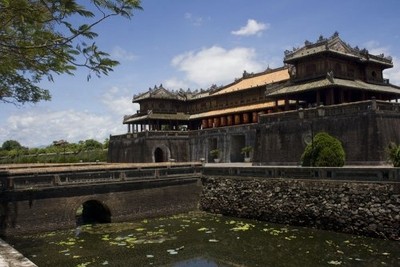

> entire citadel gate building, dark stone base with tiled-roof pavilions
[109,33,400,164]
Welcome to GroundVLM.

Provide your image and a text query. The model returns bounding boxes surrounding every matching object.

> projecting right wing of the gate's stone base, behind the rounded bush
[254,100,400,165]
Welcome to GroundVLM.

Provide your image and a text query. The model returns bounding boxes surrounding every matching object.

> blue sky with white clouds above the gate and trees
[0,0,400,148]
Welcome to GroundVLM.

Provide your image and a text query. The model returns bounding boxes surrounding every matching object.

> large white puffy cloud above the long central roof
[172,46,265,88]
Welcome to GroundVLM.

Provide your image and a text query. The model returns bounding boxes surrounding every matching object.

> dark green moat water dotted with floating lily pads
[7,212,400,267]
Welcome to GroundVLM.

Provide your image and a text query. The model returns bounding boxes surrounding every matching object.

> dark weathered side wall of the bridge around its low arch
[0,178,201,235]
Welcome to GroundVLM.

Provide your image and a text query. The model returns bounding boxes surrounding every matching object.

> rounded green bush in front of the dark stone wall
[301,132,346,167]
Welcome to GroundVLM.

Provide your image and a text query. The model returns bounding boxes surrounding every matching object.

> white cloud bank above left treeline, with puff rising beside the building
[0,87,139,147]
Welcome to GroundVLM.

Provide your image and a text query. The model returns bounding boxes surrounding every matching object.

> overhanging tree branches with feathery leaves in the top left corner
[0,0,141,104]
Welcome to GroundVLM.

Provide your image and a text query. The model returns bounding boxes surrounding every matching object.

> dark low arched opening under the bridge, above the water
[76,200,111,225]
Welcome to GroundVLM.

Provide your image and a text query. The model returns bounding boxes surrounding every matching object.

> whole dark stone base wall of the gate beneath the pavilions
[108,100,400,165]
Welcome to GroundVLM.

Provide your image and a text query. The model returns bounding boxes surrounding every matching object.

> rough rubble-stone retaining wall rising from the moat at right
[200,176,400,240]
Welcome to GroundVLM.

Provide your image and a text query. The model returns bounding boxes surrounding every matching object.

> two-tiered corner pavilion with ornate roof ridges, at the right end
[266,33,400,106]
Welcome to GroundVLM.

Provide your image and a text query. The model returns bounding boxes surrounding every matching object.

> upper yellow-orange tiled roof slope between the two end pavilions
[210,68,290,96]
